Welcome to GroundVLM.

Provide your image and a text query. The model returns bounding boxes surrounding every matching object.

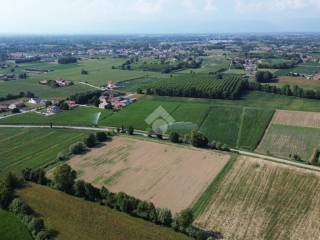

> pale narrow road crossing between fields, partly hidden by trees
[0,125,320,172]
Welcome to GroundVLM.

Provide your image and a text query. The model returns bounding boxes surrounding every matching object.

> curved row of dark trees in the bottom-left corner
[0,173,53,240]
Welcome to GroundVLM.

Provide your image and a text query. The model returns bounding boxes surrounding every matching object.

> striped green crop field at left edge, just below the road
[0,128,85,175]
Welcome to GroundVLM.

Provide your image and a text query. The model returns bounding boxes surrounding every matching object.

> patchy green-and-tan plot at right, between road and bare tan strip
[257,124,320,161]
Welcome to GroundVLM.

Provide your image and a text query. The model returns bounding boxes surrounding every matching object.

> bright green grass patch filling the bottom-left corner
[0,209,33,240]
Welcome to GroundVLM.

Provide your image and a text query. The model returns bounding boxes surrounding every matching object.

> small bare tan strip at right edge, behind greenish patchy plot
[272,110,320,128]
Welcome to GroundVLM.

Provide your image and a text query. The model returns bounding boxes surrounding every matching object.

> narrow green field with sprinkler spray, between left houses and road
[0,107,112,126]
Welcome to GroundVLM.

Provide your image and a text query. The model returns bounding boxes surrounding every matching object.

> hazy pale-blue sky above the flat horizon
[0,0,320,34]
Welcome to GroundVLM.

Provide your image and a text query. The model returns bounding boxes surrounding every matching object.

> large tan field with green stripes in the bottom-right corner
[196,156,320,240]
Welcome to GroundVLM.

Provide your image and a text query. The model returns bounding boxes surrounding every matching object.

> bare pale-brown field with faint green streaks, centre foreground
[69,137,230,212]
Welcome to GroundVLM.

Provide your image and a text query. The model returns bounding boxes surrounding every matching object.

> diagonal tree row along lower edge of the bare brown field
[22,164,215,240]
